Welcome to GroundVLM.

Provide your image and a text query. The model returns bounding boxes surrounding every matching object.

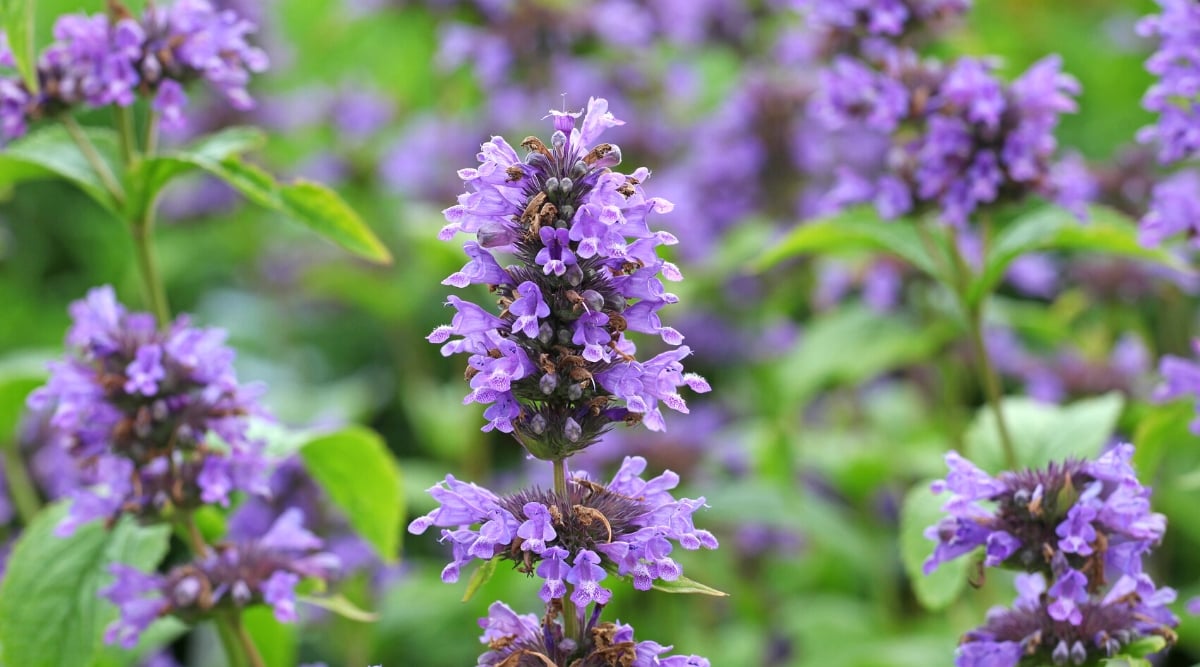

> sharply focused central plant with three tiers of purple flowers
[409,98,718,667]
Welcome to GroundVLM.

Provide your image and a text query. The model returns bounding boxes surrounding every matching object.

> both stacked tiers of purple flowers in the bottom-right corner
[925,444,1176,667]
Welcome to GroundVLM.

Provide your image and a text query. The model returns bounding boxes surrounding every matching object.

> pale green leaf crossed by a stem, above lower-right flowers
[966,391,1124,473]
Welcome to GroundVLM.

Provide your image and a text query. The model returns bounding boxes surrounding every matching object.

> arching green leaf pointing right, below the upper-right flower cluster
[967,205,1187,304]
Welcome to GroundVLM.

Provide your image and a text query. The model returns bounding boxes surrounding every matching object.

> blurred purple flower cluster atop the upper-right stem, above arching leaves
[814,52,1090,227]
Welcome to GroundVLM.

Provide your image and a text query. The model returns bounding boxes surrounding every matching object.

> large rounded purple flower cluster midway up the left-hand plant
[29,287,266,535]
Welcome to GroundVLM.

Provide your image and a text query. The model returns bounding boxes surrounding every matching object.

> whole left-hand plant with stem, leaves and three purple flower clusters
[0,0,388,667]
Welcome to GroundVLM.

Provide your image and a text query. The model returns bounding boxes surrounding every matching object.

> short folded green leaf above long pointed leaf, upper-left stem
[131,127,266,217]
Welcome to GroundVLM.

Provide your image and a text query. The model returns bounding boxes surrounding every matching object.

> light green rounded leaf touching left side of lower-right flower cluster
[900,480,971,611]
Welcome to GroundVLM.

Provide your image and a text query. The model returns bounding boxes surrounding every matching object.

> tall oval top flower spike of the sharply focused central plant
[428,98,709,459]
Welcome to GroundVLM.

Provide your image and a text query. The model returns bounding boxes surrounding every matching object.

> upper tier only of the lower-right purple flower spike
[925,445,1166,583]
